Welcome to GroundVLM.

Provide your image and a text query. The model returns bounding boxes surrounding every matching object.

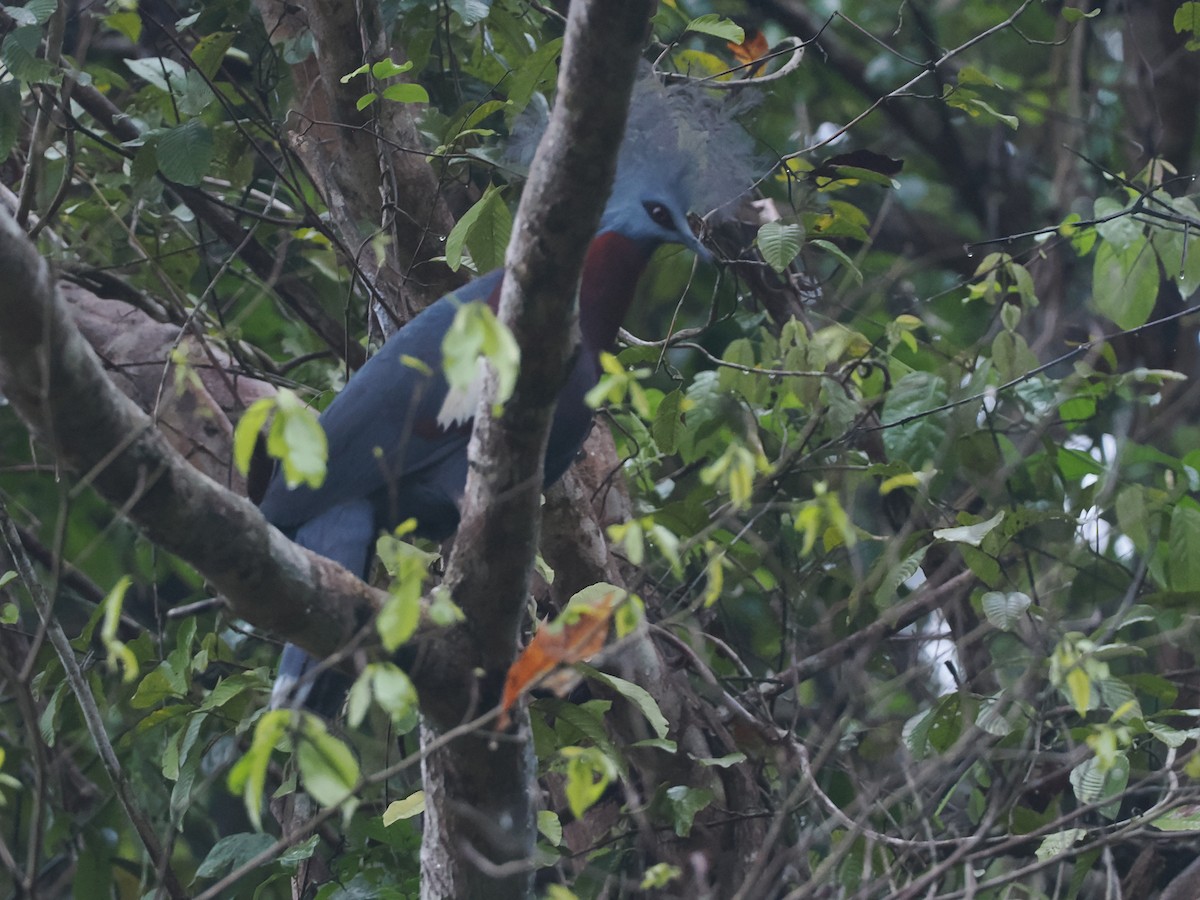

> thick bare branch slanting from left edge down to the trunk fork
[0,208,383,672]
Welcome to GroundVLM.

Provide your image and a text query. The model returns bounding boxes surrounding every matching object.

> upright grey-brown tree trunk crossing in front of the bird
[412,0,654,900]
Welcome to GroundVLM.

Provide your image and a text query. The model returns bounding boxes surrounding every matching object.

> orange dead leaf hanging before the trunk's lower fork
[498,590,623,728]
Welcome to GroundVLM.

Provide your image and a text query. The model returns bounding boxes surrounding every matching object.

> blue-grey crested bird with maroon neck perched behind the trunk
[259,74,751,718]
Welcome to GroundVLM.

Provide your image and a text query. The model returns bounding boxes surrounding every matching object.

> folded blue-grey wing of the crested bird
[259,270,503,528]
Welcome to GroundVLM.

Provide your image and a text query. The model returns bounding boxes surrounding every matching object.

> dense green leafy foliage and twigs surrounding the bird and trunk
[0,0,1200,898]
